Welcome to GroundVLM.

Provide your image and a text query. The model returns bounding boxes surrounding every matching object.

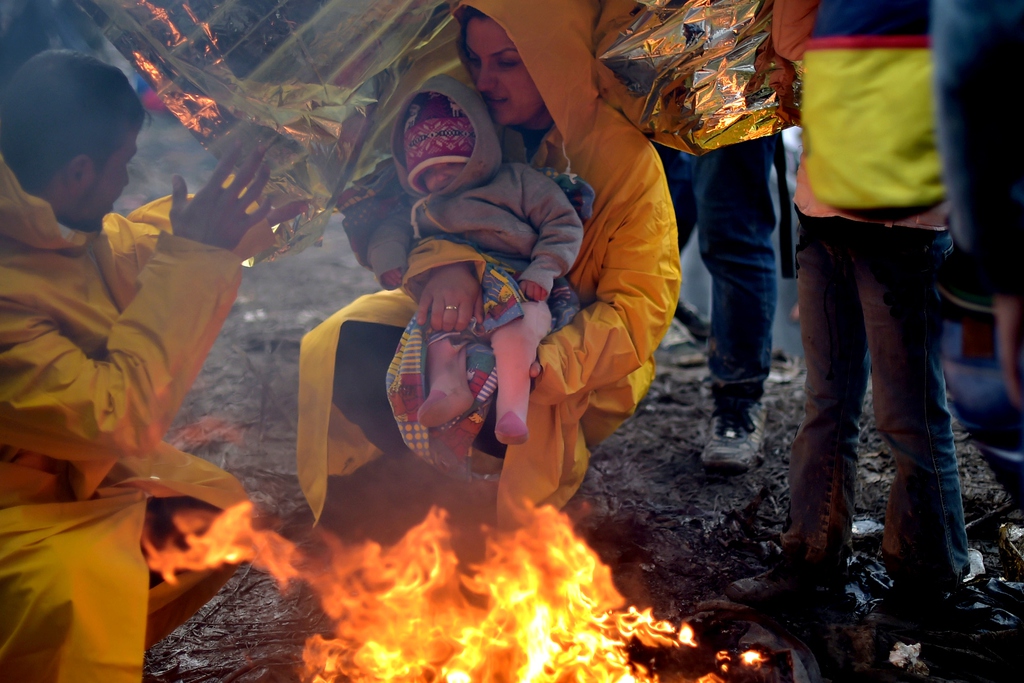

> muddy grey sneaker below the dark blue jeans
[700,398,767,474]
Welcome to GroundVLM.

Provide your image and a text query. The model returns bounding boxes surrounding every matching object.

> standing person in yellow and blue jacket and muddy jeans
[726,0,969,611]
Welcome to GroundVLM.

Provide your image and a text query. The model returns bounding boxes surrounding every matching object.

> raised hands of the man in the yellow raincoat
[171,146,306,250]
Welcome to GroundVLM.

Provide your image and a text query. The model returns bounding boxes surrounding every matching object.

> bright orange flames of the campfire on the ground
[150,503,806,683]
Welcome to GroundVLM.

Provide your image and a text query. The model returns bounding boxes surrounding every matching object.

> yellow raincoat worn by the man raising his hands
[0,159,246,683]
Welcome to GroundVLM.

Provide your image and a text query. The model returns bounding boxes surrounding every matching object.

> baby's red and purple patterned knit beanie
[404,92,476,193]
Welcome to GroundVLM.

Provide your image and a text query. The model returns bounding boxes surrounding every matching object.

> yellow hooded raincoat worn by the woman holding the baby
[297,0,680,524]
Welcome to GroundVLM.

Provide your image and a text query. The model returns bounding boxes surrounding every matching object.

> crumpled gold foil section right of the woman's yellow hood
[599,0,799,154]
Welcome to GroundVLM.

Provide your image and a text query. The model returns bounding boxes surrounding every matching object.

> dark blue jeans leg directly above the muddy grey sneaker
[693,135,778,400]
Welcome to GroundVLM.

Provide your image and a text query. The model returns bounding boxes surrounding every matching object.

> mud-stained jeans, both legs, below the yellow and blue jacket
[782,216,968,590]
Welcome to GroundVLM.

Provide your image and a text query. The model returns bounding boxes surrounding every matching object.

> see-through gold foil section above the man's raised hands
[76,0,459,261]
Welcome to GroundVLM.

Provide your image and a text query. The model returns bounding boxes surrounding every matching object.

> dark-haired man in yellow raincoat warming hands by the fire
[0,51,298,683]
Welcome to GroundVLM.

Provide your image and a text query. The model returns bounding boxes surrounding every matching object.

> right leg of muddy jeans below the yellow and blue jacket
[855,227,968,589]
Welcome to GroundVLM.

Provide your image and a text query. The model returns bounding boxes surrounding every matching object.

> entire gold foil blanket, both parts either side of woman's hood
[76,0,796,261]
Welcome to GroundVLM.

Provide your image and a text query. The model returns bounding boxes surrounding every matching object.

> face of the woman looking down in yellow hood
[466,16,553,130]
